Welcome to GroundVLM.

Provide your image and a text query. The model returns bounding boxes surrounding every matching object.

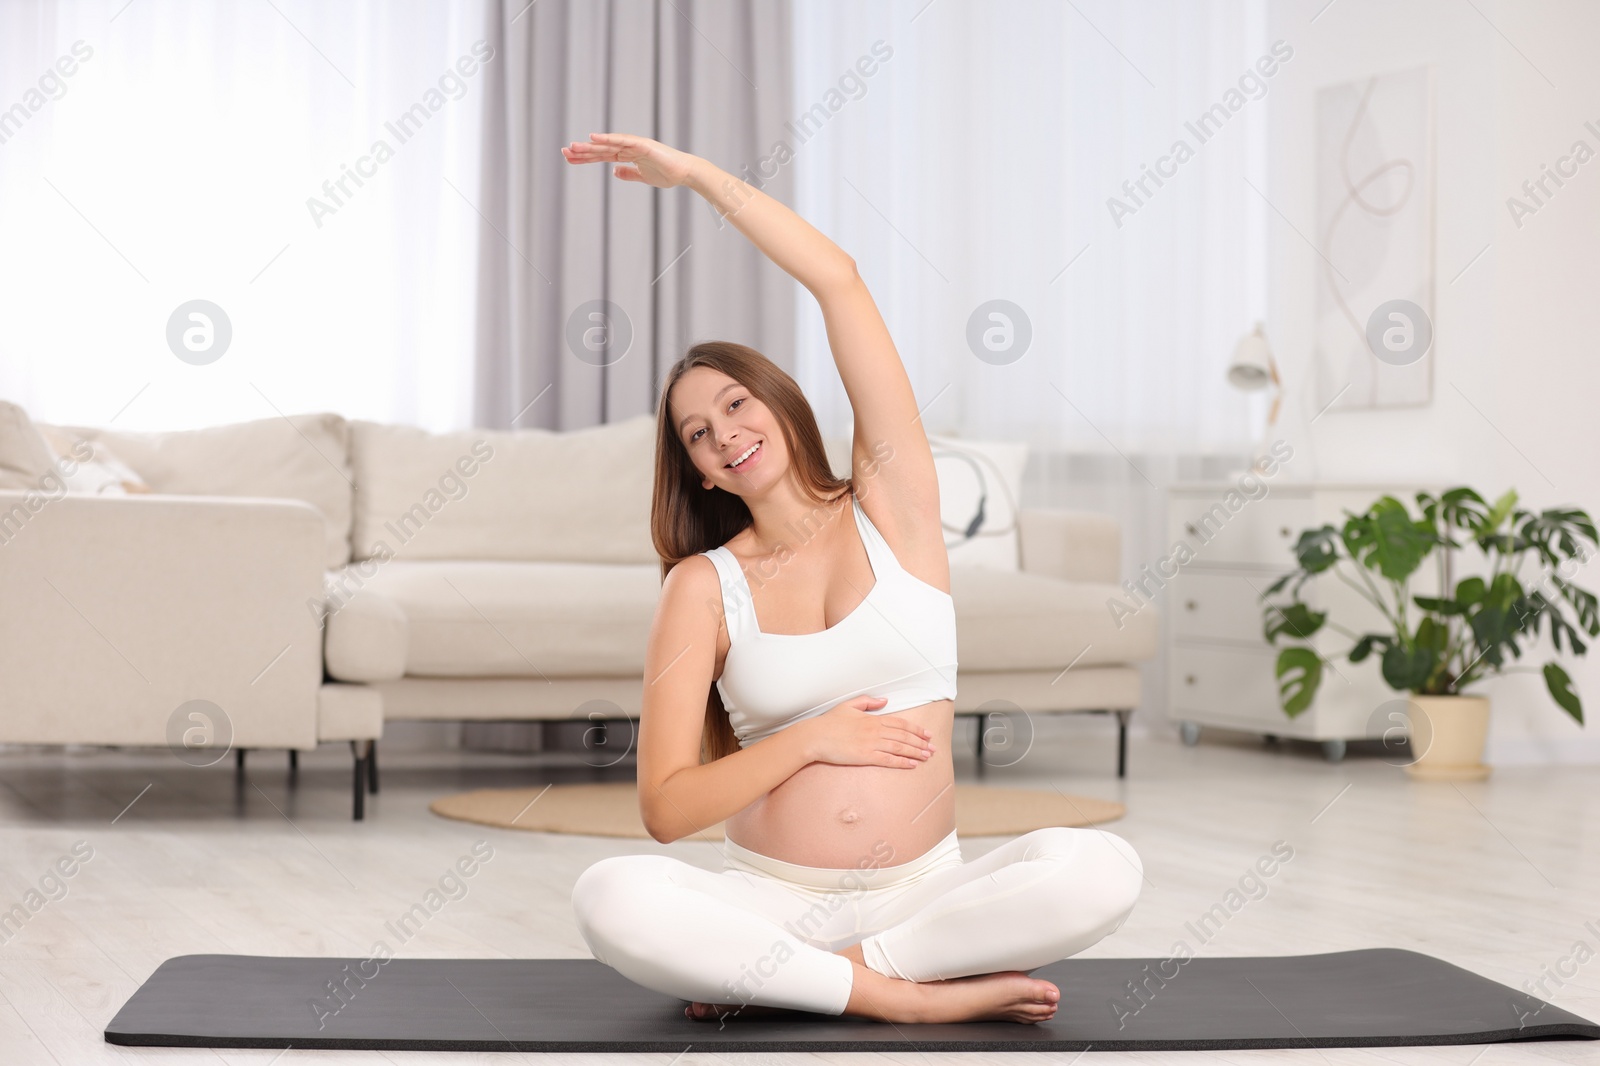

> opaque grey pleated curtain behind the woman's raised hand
[462,0,797,429]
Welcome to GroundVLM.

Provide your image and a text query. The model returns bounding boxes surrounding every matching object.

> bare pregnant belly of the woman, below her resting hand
[723,699,955,869]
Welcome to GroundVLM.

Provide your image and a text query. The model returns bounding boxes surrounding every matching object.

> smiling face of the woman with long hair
[669,367,787,496]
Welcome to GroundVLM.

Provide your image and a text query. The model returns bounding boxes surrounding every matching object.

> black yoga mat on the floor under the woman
[106,948,1600,1052]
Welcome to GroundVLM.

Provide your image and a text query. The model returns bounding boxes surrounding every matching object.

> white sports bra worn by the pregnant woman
[701,493,955,747]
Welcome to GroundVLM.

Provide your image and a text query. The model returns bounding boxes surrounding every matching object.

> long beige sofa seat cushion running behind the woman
[328,559,1158,680]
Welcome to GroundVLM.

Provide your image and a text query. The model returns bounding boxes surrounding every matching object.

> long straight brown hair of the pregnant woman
[650,341,854,763]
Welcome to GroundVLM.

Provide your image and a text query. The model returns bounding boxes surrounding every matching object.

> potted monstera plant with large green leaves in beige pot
[1261,488,1600,779]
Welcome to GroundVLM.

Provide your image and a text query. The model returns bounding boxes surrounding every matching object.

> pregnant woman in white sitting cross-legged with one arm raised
[563,133,1144,1023]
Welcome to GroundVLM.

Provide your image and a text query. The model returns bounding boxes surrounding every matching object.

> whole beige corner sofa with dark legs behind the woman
[0,402,1158,816]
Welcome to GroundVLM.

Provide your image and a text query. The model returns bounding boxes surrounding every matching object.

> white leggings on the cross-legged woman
[573,826,1144,1015]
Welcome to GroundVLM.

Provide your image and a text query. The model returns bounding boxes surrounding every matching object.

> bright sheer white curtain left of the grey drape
[0,0,494,429]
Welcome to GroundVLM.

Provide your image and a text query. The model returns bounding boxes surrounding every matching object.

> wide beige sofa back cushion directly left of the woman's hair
[350,415,661,563]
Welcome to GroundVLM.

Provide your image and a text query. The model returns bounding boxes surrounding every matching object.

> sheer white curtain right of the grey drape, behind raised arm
[789,0,1273,720]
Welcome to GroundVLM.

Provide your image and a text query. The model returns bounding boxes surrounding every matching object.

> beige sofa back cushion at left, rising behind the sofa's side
[42,415,352,568]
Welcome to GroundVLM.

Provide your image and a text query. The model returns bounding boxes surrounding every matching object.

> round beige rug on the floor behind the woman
[429,781,1126,842]
